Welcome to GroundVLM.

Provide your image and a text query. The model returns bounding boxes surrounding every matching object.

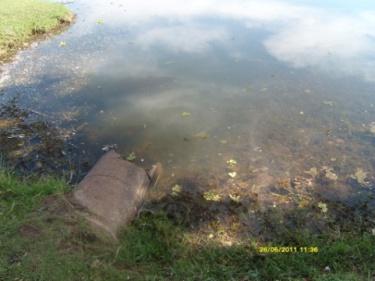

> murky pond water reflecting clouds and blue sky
[0,0,375,212]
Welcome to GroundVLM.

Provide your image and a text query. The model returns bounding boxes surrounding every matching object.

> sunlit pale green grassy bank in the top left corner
[0,0,73,59]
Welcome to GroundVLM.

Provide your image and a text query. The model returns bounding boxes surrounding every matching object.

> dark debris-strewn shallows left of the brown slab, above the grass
[0,99,96,183]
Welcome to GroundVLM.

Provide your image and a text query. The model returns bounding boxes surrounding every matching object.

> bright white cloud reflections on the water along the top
[75,0,375,81]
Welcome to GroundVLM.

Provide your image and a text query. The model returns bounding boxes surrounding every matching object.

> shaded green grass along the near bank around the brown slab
[0,168,375,281]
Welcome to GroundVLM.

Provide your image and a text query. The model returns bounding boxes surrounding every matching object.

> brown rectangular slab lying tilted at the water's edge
[72,151,151,239]
